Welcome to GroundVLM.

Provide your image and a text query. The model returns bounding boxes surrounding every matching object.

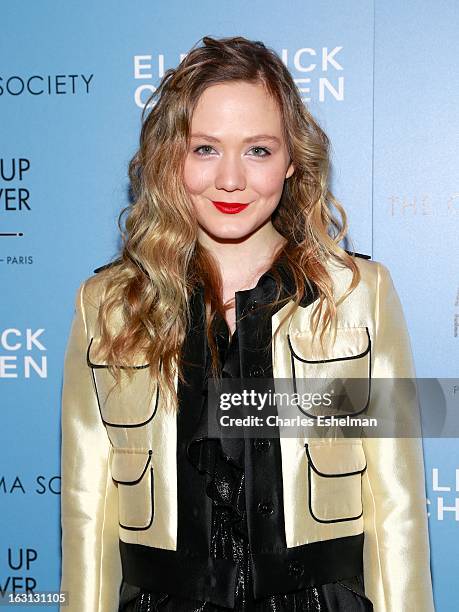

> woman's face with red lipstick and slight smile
[184,81,294,241]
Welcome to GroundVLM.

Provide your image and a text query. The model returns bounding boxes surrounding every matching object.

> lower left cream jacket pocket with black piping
[111,448,154,530]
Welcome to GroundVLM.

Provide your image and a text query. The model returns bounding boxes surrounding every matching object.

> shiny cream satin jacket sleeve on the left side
[60,281,122,612]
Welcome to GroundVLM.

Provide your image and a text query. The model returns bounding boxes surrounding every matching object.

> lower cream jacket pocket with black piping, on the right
[305,440,367,523]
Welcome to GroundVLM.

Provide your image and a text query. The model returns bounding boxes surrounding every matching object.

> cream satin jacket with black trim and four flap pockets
[61,257,434,612]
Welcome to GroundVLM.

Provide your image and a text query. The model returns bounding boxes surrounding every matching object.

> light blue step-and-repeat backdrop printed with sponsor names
[0,0,459,612]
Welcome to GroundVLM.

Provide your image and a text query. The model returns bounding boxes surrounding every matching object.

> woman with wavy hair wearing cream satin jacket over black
[61,37,433,612]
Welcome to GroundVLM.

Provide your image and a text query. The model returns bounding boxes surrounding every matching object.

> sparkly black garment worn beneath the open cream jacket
[119,316,373,612]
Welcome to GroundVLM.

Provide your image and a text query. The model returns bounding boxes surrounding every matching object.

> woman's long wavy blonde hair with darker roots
[91,36,360,408]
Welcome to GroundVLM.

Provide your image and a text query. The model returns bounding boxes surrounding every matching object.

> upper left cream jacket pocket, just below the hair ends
[86,338,159,427]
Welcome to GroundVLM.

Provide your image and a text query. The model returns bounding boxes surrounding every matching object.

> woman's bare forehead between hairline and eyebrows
[192,81,282,135]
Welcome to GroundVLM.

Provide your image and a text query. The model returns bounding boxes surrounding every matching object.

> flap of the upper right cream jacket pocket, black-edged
[288,327,371,363]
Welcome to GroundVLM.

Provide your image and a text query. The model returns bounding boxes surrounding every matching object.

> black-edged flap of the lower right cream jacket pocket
[305,441,367,476]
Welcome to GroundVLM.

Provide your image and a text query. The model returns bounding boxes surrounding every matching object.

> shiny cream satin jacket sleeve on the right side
[362,264,434,612]
